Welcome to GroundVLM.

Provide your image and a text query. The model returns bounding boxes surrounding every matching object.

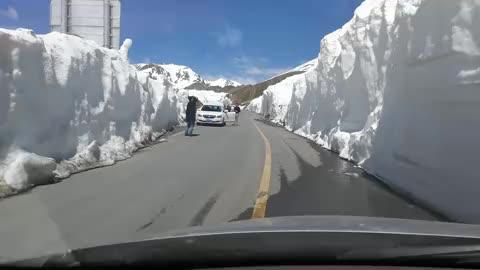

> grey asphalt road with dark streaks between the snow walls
[0,113,438,261]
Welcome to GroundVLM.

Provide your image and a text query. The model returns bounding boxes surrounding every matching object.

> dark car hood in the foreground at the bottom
[8,216,480,267]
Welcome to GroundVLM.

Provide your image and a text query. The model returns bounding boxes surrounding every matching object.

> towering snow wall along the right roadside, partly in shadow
[249,0,480,222]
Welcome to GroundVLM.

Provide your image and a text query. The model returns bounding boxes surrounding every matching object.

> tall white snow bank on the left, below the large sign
[0,29,177,189]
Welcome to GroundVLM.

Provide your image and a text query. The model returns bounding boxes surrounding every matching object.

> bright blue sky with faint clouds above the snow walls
[0,0,361,82]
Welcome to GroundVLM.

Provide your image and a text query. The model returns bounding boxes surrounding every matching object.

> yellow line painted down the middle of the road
[252,121,272,219]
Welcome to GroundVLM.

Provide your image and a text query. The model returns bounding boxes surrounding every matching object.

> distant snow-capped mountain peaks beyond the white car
[135,64,241,90]
